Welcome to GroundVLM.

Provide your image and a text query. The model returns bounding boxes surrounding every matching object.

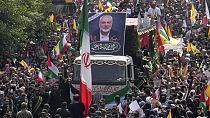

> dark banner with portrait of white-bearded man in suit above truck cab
[88,12,126,55]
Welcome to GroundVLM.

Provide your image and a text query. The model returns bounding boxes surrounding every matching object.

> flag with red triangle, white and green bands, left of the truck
[47,54,59,78]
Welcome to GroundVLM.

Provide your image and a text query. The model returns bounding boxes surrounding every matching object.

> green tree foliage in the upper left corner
[0,0,52,56]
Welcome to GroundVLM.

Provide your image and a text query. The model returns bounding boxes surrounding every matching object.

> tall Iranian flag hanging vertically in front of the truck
[79,0,92,116]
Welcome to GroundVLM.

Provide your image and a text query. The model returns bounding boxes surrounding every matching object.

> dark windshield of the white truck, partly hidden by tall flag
[73,64,126,84]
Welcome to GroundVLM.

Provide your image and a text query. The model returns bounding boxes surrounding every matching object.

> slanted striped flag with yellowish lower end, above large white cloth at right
[159,24,170,44]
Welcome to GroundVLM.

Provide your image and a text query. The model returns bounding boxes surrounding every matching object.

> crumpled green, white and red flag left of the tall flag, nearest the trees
[54,33,70,59]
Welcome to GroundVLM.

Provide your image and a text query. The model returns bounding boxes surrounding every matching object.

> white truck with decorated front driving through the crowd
[72,55,134,102]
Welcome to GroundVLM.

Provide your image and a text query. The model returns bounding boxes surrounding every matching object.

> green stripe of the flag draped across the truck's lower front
[105,85,130,104]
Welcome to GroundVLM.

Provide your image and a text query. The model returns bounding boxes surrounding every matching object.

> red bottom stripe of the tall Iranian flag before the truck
[80,81,92,116]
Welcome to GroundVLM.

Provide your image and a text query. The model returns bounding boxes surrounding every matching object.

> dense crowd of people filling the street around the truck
[0,0,210,118]
